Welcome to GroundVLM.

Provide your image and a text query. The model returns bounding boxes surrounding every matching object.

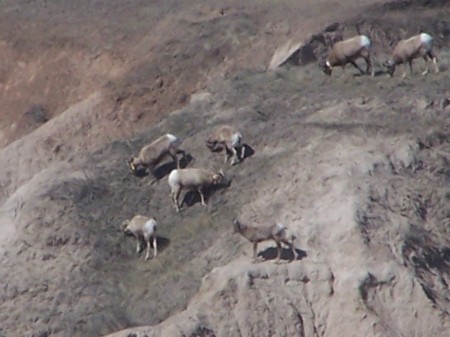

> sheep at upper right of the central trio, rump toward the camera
[206,125,245,165]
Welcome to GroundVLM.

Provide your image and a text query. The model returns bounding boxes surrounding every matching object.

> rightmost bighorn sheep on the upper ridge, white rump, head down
[384,33,439,77]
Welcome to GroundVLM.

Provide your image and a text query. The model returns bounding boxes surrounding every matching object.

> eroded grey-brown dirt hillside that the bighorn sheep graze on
[0,1,450,337]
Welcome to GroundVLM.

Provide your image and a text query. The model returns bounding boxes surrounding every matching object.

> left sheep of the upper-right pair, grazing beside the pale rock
[321,35,375,76]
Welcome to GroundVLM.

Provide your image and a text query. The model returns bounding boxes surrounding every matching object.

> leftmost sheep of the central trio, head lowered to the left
[128,133,186,174]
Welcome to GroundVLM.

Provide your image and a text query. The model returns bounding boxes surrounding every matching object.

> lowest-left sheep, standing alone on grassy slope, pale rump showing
[122,215,158,260]
